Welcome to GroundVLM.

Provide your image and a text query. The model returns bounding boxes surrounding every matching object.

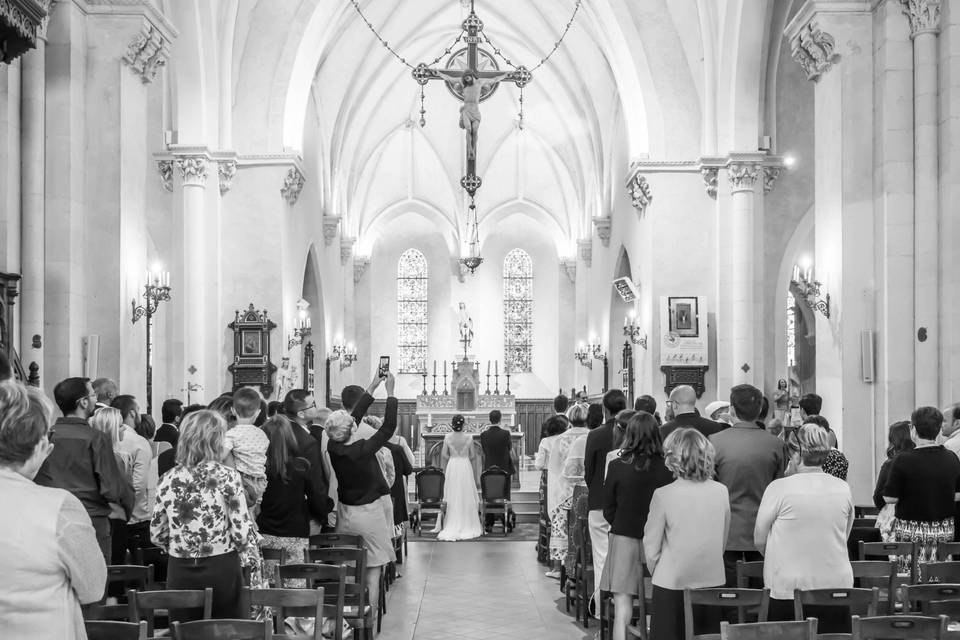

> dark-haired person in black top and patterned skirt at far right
[883,407,960,564]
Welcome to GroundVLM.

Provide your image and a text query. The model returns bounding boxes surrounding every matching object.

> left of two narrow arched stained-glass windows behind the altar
[397,249,427,373]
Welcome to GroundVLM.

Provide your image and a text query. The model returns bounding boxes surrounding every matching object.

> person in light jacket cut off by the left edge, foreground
[0,380,112,640]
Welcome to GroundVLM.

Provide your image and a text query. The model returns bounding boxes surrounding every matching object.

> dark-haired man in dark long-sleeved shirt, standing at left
[34,378,134,564]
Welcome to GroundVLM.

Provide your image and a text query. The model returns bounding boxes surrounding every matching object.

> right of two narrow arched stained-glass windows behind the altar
[503,249,533,373]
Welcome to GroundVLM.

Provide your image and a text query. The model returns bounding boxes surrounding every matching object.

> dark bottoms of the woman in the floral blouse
[167,551,242,622]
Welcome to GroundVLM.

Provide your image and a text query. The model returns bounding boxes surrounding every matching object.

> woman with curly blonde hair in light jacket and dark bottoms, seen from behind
[643,427,730,640]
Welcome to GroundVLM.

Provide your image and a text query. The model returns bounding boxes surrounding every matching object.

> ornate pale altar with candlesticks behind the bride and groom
[417,358,523,488]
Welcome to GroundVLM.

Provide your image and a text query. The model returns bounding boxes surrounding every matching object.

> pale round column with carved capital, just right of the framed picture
[721,162,762,392]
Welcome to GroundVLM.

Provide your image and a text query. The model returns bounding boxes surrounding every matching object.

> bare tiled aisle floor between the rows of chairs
[378,540,597,640]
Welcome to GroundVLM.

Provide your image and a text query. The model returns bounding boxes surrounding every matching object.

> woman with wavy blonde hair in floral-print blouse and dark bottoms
[150,410,260,618]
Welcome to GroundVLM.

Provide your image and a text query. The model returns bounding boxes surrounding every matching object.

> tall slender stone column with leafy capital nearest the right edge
[901,0,946,406]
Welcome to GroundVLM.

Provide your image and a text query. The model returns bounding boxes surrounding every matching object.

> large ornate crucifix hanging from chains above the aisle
[413,0,533,198]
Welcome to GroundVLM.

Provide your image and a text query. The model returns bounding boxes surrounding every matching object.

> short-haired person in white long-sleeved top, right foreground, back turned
[753,424,854,632]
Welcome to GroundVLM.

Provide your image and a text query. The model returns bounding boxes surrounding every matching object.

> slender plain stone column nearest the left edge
[20,37,47,387]
